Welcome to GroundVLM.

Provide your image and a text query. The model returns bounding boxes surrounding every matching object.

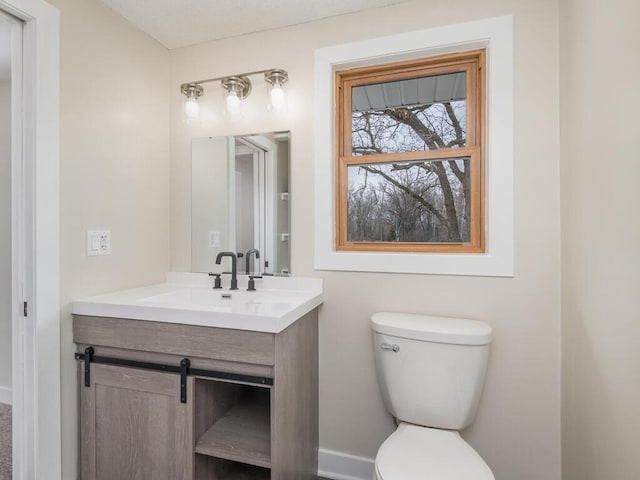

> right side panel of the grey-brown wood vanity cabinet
[271,309,318,480]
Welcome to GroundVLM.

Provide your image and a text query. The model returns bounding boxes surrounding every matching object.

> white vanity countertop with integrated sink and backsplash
[72,272,323,333]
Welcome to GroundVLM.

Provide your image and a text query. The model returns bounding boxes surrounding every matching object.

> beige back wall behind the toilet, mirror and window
[170,0,560,480]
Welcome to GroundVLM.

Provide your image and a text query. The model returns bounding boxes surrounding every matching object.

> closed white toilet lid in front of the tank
[375,423,495,480]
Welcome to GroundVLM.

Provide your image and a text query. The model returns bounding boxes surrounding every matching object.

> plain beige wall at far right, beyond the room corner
[560,0,640,480]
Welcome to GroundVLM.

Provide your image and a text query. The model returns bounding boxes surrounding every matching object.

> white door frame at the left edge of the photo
[0,0,62,480]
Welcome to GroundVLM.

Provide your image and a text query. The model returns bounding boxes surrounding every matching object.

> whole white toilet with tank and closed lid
[371,312,495,480]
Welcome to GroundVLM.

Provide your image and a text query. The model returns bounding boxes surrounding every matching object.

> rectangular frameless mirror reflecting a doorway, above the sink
[191,132,290,275]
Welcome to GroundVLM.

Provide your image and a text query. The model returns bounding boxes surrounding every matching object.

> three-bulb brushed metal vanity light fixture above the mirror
[180,68,289,119]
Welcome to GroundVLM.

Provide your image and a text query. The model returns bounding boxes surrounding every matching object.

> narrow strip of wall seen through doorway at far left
[0,80,12,392]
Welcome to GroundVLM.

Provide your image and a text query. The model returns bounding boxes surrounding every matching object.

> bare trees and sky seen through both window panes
[347,91,471,242]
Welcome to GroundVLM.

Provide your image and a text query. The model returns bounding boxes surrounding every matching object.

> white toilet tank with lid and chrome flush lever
[371,312,491,430]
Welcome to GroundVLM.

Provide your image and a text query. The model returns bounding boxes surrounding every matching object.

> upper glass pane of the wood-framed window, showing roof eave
[351,72,467,155]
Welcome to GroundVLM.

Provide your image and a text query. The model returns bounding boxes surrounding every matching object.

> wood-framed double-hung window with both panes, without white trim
[335,50,485,253]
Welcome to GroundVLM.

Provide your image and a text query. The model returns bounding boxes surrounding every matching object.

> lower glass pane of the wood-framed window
[347,157,471,243]
